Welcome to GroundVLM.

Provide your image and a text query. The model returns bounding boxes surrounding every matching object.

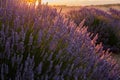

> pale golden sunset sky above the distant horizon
[42,0,120,6]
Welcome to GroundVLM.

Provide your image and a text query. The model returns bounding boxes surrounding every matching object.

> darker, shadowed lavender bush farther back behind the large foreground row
[68,7,120,53]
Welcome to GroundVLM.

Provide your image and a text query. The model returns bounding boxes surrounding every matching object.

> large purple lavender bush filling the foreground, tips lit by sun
[0,0,120,80]
